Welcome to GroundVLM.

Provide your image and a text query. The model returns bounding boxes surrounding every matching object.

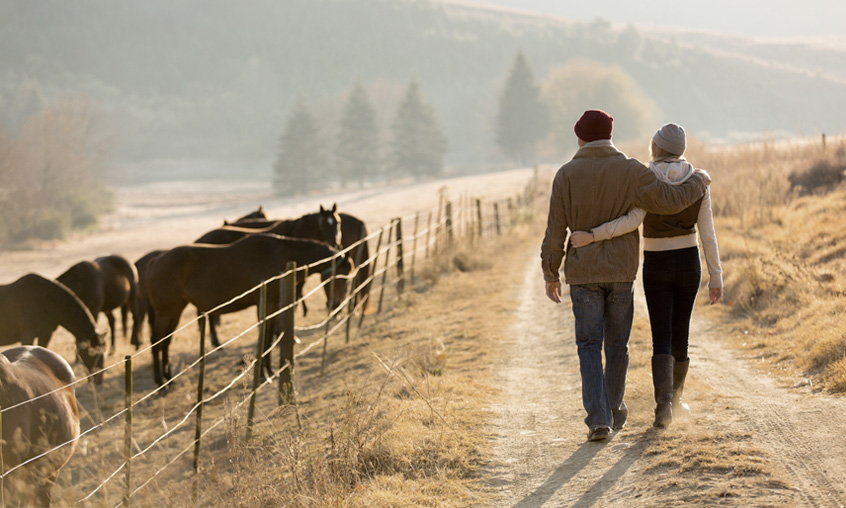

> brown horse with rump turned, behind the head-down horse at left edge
[56,255,138,349]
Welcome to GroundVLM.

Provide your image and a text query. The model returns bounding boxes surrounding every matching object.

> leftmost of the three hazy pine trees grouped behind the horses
[273,95,324,195]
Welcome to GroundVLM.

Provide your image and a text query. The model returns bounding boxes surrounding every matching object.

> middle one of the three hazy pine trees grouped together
[335,83,379,187]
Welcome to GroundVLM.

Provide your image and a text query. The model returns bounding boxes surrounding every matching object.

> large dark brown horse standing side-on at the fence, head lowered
[145,234,352,385]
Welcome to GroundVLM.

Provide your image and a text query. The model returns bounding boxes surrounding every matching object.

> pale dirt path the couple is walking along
[485,249,846,508]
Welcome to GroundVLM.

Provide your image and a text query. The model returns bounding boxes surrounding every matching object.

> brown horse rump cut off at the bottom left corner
[0,346,79,507]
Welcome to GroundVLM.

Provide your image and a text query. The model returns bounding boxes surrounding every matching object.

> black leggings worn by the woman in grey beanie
[643,247,702,362]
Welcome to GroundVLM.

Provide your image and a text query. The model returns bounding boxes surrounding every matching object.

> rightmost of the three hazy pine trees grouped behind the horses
[388,80,447,179]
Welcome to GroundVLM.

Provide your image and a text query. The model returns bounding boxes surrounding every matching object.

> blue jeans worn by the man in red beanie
[570,282,634,429]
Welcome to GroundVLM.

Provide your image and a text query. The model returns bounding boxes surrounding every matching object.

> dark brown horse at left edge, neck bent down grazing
[0,273,105,383]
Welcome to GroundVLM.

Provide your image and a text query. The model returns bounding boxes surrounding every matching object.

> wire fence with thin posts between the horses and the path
[0,177,537,506]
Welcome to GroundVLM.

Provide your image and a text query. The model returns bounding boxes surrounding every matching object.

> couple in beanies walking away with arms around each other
[541,110,723,441]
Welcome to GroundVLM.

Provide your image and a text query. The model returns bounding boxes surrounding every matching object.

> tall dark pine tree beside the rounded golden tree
[496,51,549,165]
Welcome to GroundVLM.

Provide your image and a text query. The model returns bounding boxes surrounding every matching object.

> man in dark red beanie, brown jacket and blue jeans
[541,110,705,441]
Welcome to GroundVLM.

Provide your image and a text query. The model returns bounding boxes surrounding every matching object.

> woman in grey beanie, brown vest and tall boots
[571,123,723,427]
